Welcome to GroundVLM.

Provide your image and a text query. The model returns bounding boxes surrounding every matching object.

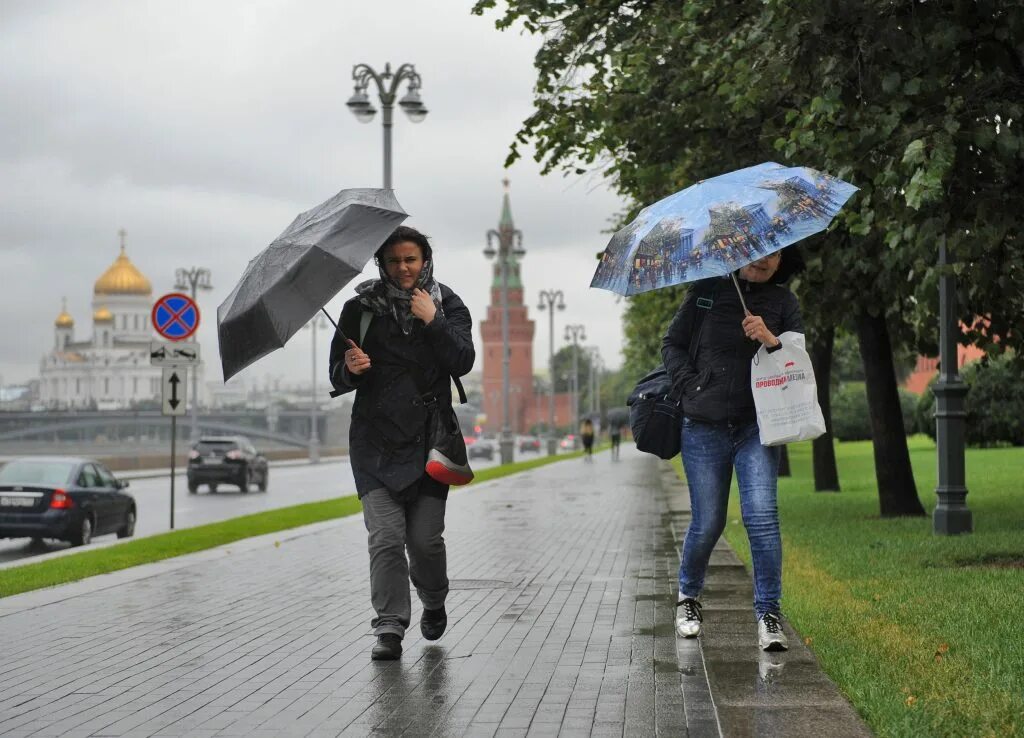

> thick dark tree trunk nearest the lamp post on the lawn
[857,310,925,518]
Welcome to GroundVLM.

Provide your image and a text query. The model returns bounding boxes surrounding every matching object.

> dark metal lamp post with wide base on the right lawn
[932,238,974,535]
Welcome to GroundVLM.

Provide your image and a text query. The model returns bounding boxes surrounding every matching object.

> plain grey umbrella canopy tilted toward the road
[217,188,408,382]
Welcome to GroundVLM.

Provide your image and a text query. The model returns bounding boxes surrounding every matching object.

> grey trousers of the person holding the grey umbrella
[360,487,449,638]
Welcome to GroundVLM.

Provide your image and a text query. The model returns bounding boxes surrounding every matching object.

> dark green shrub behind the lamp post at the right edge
[916,356,1024,447]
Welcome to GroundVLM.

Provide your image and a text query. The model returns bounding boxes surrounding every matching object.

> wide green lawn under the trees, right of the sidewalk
[708,437,1024,737]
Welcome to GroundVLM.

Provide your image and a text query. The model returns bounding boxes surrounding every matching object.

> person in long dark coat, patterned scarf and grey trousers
[330,226,475,660]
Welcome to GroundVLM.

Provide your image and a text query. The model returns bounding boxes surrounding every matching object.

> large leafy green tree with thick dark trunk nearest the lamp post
[475,0,1024,516]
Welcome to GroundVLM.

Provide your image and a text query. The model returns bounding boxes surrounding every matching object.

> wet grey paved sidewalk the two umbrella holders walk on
[0,448,866,738]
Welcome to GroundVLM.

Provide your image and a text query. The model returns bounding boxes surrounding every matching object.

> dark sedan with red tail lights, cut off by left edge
[0,457,137,546]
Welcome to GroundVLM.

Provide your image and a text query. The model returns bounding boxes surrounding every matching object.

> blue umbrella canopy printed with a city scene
[590,162,857,295]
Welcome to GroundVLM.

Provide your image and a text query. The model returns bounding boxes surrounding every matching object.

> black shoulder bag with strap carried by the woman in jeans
[626,279,719,459]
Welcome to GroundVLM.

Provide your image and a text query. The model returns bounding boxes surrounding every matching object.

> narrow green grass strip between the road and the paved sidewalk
[0,444,593,597]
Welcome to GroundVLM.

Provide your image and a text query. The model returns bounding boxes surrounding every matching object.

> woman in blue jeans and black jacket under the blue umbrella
[662,249,804,651]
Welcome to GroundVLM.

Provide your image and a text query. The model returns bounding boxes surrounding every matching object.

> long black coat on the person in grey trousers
[330,283,476,500]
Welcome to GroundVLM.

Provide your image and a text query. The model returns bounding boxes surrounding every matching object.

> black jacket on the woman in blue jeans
[662,277,804,425]
